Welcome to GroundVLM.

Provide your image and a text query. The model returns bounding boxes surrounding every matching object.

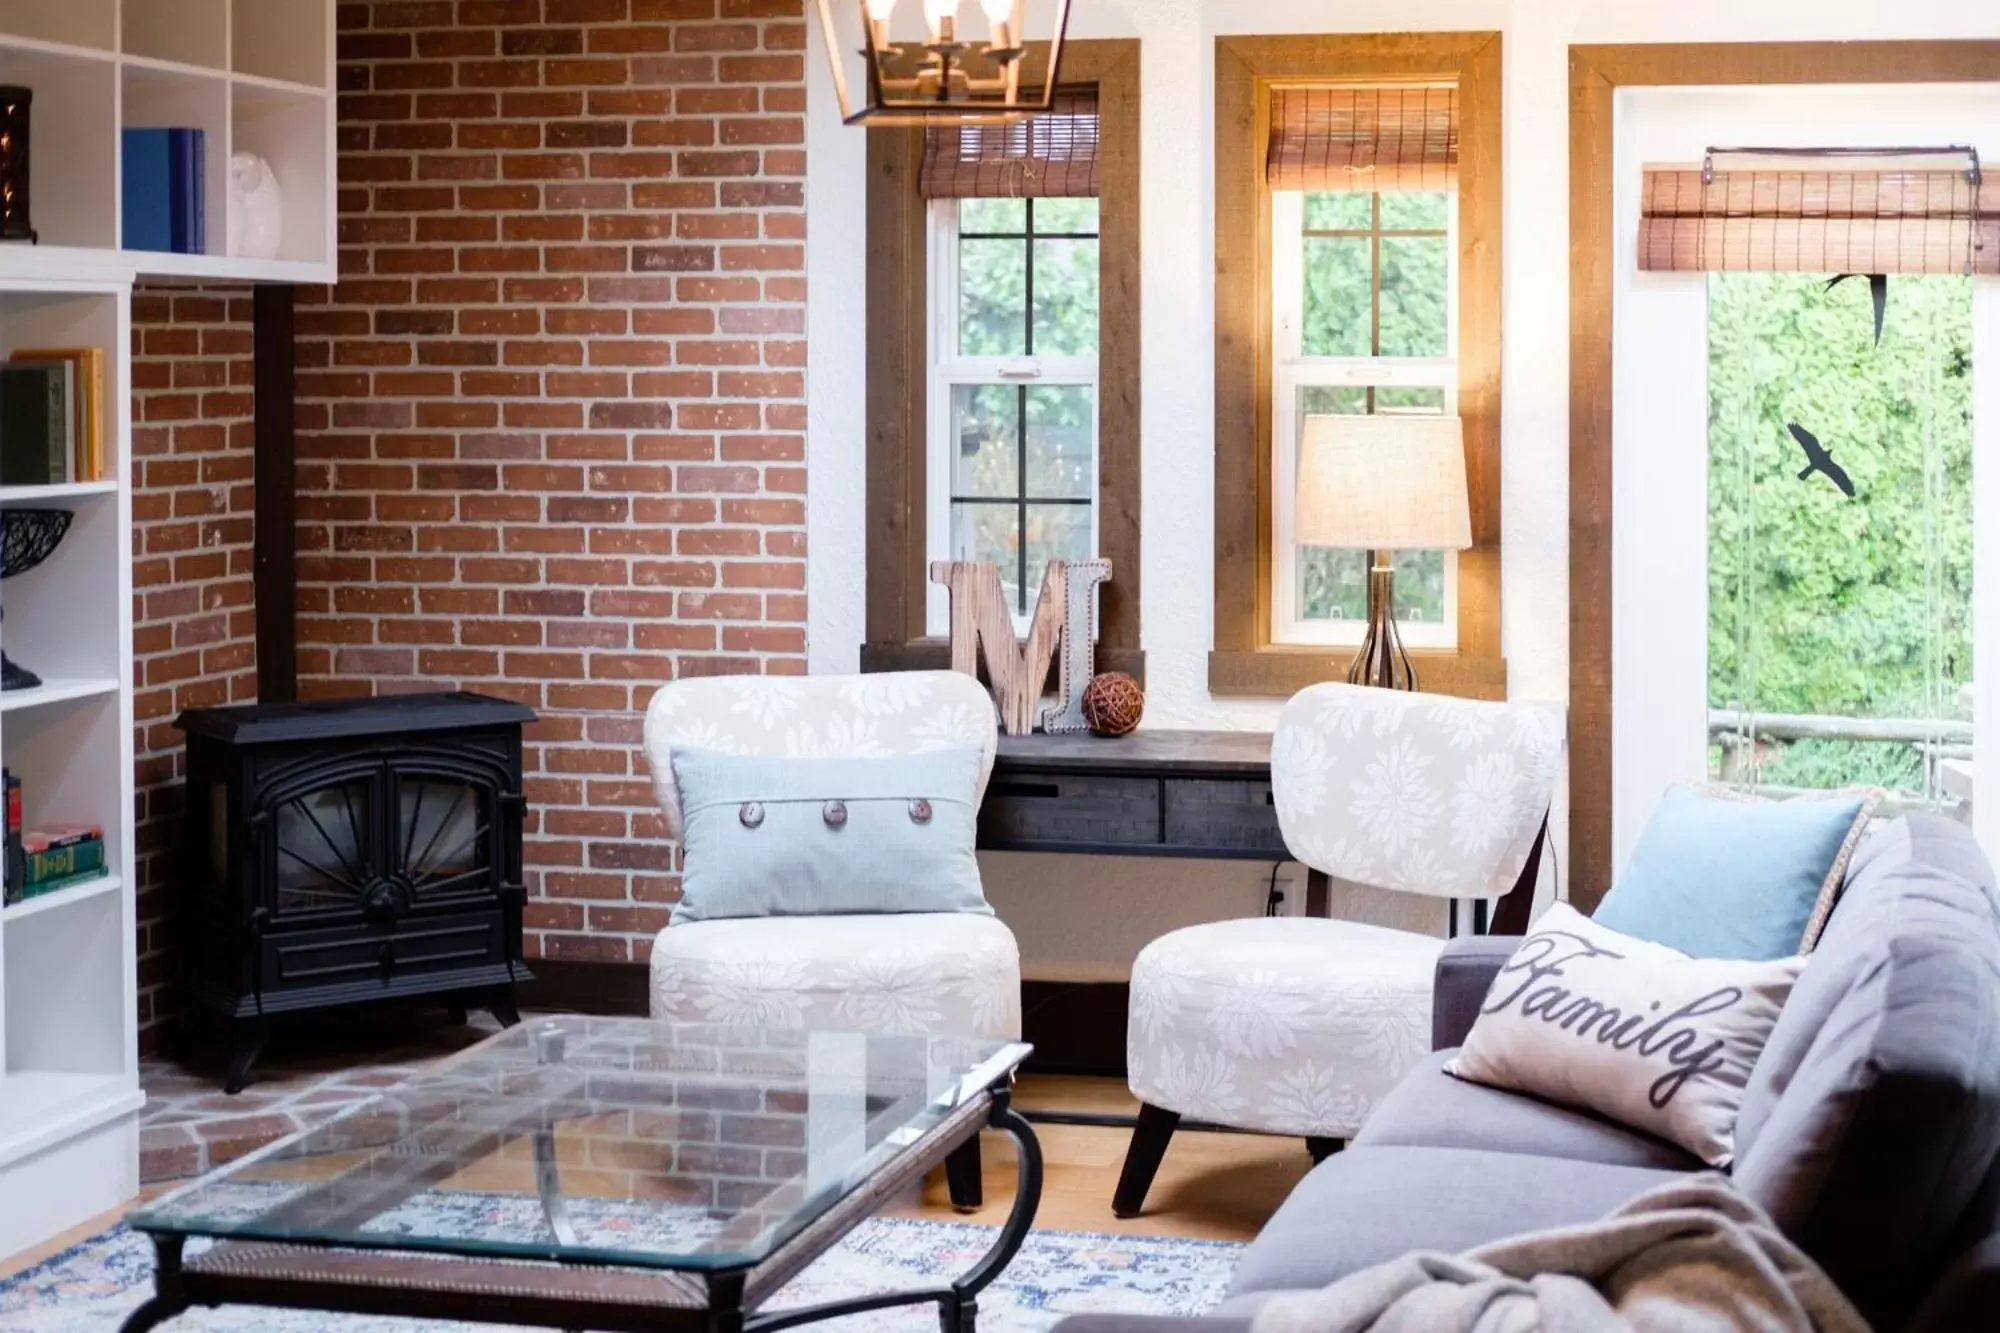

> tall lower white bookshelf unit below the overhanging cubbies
[0,278,144,1255]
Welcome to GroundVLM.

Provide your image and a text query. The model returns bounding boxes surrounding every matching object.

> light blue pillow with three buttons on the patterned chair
[674,749,992,925]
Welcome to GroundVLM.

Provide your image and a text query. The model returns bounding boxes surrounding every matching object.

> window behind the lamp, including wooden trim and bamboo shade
[1208,32,1506,699]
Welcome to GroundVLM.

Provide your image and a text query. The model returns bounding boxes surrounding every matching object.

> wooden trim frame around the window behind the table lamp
[1208,32,1506,699]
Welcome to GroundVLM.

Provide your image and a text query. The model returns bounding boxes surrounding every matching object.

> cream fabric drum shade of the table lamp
[1298,416,1472,550]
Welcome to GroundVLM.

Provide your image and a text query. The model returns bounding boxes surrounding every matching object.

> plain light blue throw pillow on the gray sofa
[1592,787,1878,961]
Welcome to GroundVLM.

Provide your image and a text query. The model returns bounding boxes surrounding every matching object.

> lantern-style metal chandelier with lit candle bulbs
[818,0,1070,124]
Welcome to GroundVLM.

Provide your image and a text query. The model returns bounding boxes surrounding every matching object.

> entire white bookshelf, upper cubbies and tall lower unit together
[0,0,336,1259]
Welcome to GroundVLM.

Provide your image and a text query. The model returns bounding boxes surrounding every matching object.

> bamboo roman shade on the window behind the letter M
[918,88,1098,198]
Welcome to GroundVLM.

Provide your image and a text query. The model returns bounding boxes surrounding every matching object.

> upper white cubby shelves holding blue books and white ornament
[0,0,336,282]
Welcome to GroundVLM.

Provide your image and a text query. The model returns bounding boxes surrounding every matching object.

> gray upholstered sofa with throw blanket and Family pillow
[1060,817,2000,1333]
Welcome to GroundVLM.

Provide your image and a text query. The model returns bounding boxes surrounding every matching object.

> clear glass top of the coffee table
[130,1017,1028,1271]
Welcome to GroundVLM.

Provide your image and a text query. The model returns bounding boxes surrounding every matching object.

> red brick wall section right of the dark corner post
[298,0,806,961]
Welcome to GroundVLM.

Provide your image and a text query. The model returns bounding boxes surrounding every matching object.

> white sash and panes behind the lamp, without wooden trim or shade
[1270,190,1458,648]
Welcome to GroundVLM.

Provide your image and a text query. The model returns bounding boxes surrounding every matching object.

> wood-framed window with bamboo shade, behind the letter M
[856,38,1146,679]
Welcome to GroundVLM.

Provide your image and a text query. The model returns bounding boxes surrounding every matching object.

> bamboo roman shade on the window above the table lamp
[1266,86,1458,190]
